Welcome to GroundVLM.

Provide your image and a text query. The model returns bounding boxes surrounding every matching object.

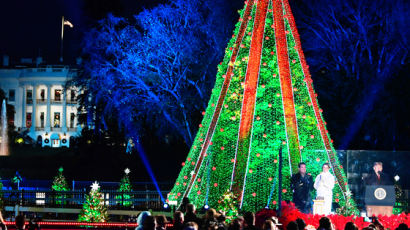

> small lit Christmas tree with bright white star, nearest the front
[78,181,108,222]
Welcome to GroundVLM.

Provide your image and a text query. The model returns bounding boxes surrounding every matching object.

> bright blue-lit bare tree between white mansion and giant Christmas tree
[76,0,237,145]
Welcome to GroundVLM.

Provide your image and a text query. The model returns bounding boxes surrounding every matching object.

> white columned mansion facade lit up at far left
[0,66,81,147]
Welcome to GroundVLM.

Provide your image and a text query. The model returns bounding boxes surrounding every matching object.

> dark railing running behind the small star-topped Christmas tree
[0,190,167,210]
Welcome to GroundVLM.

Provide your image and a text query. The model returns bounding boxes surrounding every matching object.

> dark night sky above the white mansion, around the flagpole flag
[0,0,164,64]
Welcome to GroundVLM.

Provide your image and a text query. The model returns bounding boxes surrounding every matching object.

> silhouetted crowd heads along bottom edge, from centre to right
[136,204,408,230]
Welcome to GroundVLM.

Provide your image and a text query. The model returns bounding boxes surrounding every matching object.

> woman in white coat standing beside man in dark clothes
[314,163,335,215]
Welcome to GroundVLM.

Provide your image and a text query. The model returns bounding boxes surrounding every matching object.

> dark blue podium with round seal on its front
[364,185,396,217]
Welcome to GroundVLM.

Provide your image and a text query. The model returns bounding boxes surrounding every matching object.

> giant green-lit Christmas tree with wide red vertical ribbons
[168,0,356,212]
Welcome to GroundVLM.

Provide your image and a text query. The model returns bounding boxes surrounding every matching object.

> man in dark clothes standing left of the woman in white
[290,162,313,213]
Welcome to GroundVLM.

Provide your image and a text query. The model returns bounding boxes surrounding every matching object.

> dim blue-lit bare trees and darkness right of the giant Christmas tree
[291,0,410,149]
